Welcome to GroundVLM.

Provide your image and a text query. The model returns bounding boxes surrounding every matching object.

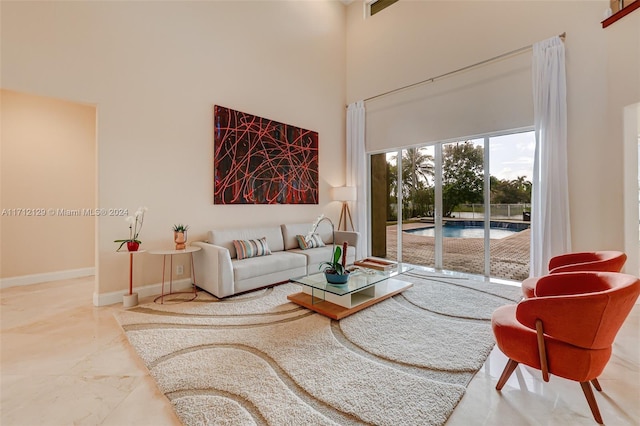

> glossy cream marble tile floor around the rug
[0,277,640,426]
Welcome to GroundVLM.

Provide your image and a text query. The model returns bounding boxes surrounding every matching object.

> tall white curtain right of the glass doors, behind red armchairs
[530,37,571,276]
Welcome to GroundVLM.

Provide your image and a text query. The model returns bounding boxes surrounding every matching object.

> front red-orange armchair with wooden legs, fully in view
[491,272,640,424]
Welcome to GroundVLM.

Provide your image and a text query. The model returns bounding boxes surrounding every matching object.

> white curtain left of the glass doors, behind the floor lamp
[347,101,369,259]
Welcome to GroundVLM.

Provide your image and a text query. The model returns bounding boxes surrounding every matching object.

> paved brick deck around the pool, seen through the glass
[387,223,531,281]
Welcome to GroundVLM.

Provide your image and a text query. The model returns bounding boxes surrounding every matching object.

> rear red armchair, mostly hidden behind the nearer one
[522,250,627,297]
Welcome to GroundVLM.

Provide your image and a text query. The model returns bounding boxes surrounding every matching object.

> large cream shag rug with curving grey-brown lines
[116,270,521,425]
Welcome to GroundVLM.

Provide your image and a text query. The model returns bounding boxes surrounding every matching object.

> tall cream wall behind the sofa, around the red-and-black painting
[1,1,346,300]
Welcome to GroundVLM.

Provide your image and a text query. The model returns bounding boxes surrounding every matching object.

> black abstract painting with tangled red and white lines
[213,105,318,204]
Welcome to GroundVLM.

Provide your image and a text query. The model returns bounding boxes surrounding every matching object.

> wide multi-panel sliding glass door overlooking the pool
[371,132,535,280]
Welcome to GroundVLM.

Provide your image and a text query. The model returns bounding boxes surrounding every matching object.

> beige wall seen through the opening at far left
[0,90,96,280]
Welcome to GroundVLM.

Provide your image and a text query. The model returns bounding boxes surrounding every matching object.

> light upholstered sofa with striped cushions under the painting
[192,222,360,298]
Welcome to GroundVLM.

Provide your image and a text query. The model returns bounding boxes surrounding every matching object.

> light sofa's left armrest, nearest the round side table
[191,241,235,297]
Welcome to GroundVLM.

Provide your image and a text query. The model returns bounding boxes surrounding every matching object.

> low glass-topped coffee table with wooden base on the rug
[287,263,413,320]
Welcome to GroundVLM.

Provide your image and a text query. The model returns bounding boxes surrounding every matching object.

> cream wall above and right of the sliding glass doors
[347,1,640,251]
